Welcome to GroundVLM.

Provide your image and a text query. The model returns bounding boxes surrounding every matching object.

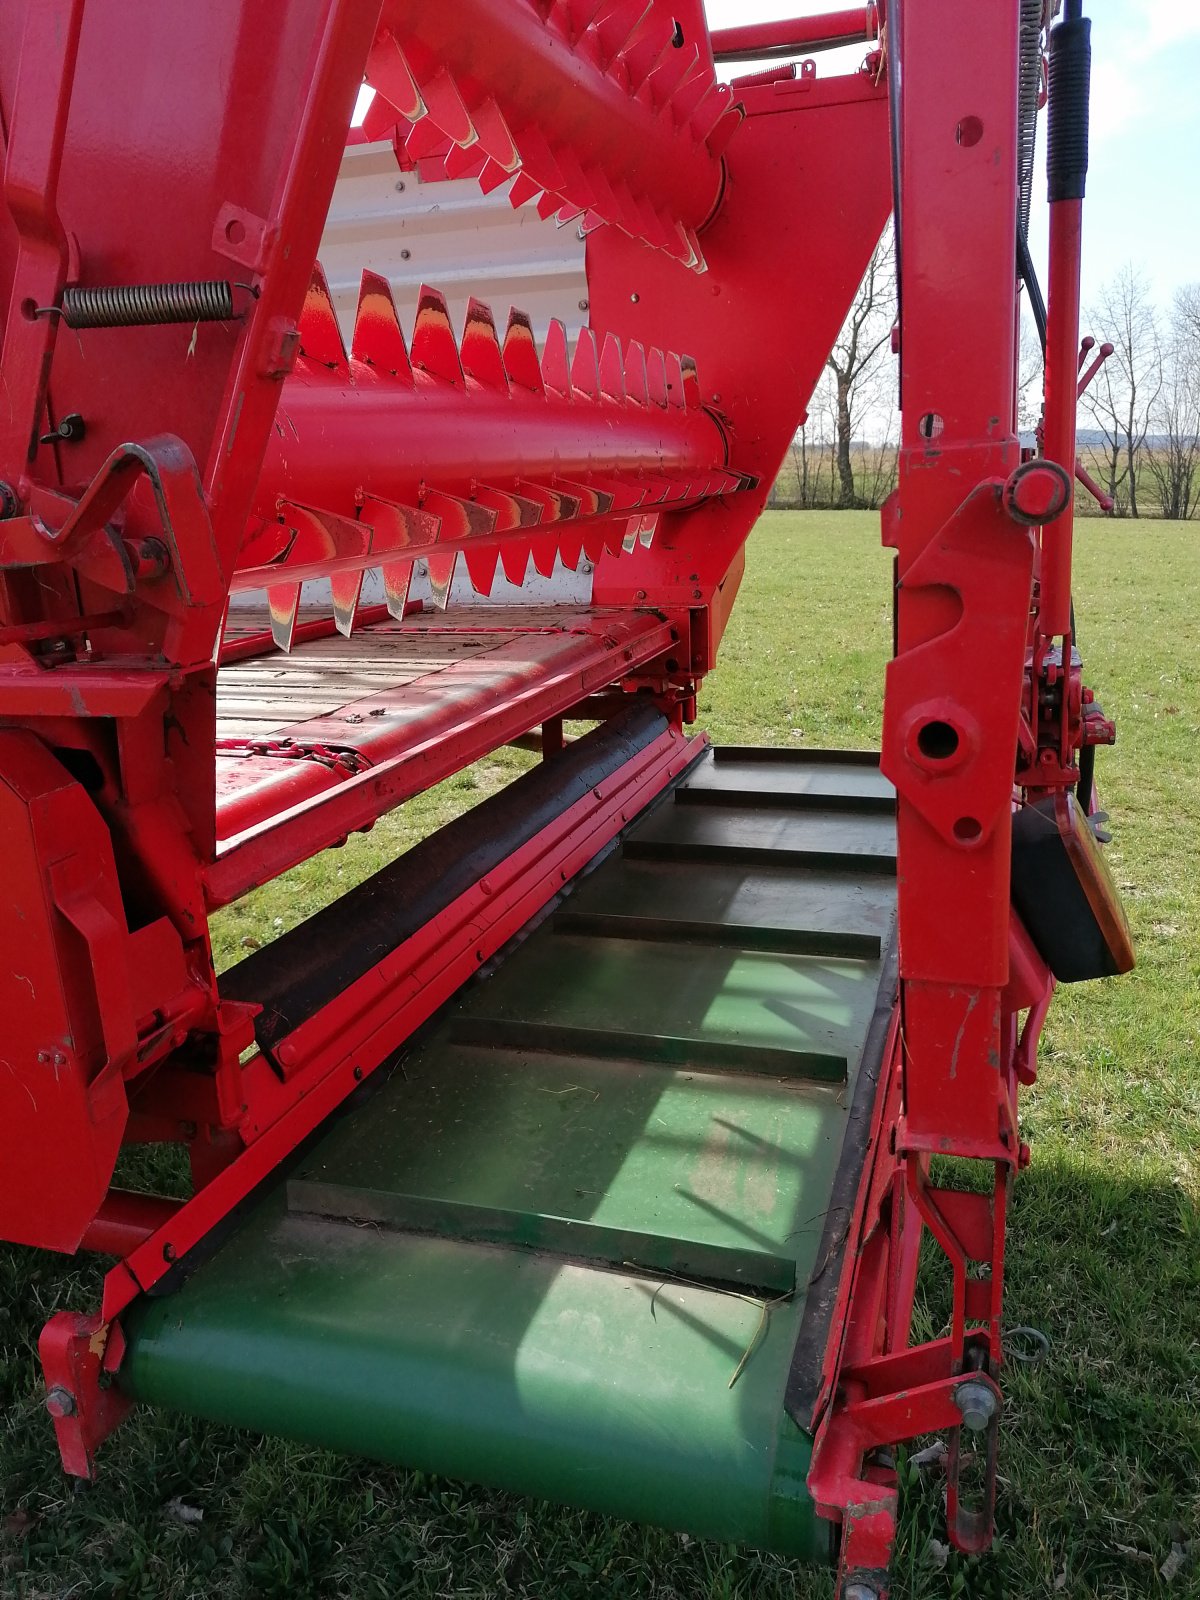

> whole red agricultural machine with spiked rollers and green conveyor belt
[0,0,1131,1600]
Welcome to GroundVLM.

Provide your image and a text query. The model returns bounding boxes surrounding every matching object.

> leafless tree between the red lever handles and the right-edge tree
[1083,266,1163,517]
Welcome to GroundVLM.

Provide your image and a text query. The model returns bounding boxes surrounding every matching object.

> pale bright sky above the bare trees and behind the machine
[706,0,1200,321]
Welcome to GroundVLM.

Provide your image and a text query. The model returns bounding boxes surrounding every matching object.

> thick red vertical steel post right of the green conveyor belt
[883,0,1032,1160]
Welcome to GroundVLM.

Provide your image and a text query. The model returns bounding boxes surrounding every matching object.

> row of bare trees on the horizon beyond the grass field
[771,240,1200,520]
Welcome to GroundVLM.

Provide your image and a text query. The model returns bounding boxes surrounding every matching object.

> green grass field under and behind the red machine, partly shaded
[0,512,1200,1600]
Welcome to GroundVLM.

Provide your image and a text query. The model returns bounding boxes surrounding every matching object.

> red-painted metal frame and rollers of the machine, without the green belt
[0,0,1112,1595]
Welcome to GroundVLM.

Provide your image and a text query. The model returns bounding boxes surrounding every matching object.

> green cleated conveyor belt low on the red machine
[122,750,894,1557]
